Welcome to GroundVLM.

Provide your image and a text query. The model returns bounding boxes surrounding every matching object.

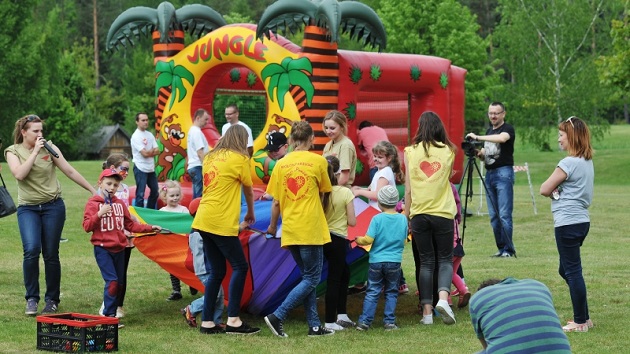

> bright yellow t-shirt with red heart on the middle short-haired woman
[267,151,332,247]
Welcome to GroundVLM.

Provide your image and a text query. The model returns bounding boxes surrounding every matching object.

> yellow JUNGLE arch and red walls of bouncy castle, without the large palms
[156,24,466,185]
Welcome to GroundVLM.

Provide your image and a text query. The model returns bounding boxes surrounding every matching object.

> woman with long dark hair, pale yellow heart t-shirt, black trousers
[405,112,457,324]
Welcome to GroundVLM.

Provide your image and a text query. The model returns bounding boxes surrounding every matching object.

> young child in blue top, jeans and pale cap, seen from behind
[356,185,407,331]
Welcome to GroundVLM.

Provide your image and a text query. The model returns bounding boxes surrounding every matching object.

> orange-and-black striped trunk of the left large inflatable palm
[152,30,184,132]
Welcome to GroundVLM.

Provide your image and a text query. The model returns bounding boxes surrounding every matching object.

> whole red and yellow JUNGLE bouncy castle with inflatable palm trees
[107,0,466,189]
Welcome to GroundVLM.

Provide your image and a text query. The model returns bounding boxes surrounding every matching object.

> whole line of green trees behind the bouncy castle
[0,0,630,159]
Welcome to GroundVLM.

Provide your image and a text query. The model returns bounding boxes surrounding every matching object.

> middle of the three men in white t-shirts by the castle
[186,108,210,199]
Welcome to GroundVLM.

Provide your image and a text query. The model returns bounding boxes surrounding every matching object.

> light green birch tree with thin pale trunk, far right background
[494,0,616,145]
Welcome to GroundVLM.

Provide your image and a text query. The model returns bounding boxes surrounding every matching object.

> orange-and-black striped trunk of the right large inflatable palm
[291,26,339,154]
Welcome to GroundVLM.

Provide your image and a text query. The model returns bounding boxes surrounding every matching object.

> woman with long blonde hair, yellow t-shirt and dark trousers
[192,125,260,334]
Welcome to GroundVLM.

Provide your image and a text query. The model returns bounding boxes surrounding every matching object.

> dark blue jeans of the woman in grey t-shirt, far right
[555,222,591,323]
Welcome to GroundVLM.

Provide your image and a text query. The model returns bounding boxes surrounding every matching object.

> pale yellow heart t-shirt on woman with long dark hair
[405,143,457,219]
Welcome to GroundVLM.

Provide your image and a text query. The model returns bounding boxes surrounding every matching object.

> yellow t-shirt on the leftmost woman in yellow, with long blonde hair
[192,149,252,236]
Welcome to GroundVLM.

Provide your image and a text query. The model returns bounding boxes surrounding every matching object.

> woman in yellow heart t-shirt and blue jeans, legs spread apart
[265,121,334,337]
